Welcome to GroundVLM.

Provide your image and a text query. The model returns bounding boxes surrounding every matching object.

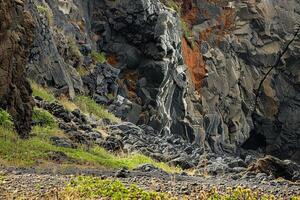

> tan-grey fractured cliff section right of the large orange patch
[188,0,300,162]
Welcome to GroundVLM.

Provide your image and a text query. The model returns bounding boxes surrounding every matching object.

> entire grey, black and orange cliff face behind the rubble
[5,0,300,161]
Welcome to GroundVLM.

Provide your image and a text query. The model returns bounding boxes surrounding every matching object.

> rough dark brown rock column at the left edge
[0,0,35,138]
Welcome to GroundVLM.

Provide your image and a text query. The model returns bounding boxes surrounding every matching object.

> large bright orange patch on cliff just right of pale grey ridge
[182,37,206,92]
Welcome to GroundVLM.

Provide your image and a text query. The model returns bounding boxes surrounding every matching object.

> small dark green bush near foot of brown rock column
[32,108,56,128]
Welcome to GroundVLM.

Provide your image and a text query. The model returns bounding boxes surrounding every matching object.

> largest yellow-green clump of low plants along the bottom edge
[61,176,169,200]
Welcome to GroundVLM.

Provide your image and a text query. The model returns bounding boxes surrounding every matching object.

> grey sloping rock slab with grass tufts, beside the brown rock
[27,0,86,98]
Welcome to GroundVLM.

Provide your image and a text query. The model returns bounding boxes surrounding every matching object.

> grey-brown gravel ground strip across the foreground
[0,165,300,199]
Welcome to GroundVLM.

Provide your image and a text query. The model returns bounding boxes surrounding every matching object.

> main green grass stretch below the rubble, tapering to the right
[0,126,180,172]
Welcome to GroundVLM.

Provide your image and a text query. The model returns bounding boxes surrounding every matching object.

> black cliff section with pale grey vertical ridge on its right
[92,0,202,145]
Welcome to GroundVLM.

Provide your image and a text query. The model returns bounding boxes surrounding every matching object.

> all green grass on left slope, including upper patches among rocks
[0,90,179,172]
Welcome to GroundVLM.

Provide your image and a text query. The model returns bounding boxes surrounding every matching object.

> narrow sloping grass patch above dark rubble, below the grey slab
[74,96,119,122]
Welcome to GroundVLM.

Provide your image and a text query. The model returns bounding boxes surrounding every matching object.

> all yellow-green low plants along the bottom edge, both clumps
[59,176,299,200]
